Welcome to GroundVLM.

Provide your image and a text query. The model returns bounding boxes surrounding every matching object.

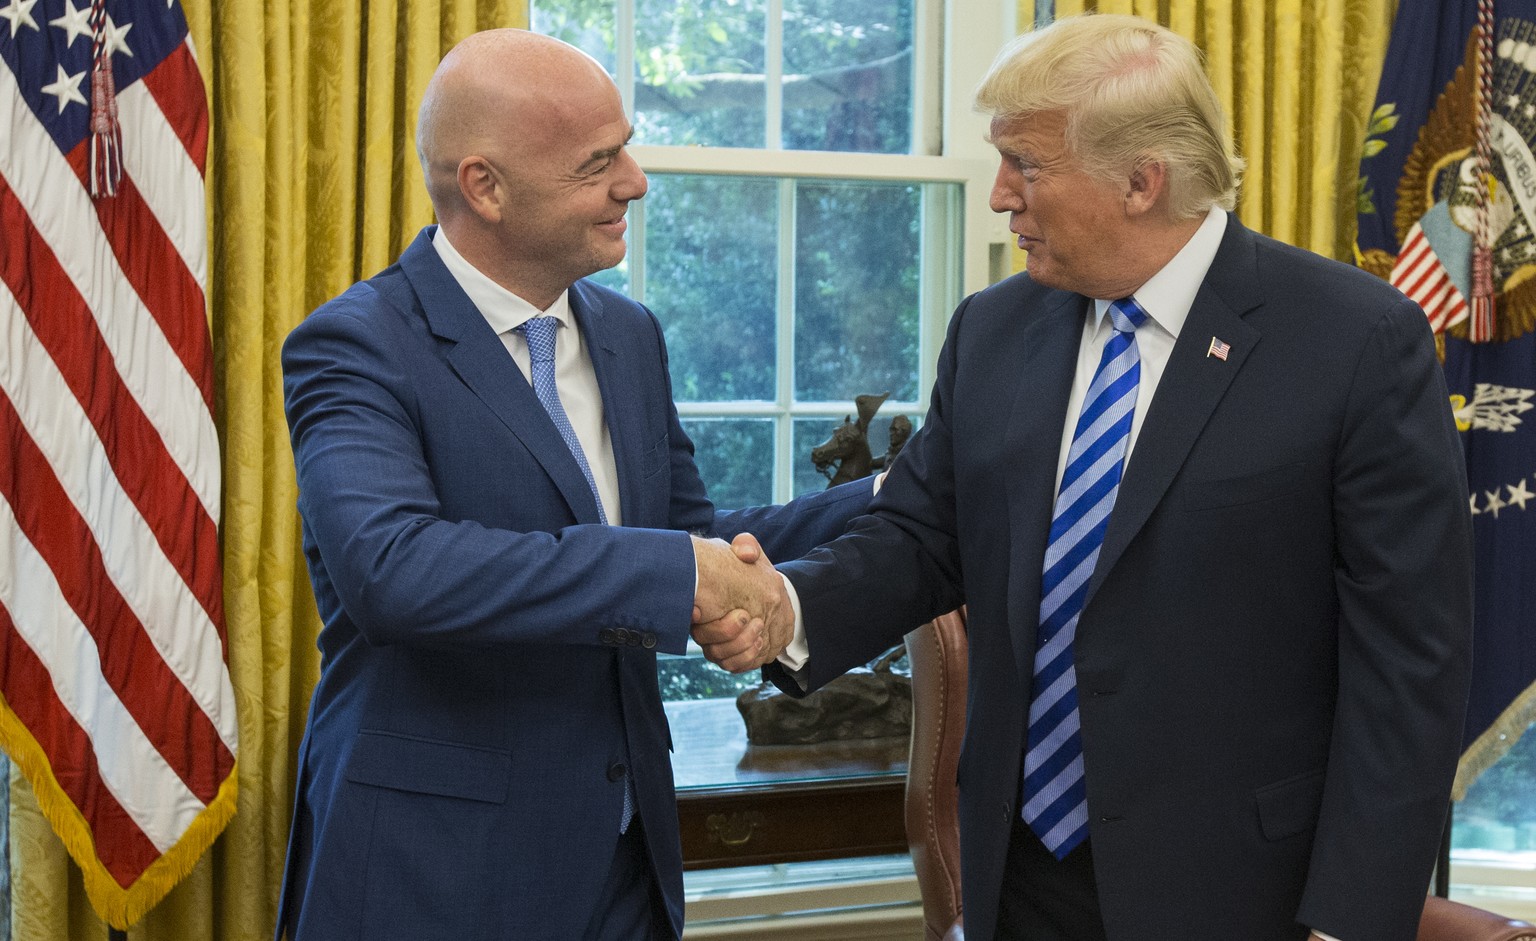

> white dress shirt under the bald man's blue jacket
[432,227,624,527]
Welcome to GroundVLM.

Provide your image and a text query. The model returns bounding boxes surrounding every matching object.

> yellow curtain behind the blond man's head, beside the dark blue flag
[1018,0,1396,261]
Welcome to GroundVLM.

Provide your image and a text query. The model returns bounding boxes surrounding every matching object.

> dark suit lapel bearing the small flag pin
[1084,216,1263,598]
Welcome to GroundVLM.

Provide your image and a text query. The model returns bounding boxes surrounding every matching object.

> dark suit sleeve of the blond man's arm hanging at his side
[1298,299,1471,941]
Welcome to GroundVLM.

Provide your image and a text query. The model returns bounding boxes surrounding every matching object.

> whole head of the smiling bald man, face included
[416,29,647,310]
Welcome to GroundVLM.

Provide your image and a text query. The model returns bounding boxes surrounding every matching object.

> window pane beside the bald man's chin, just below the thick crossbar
[645,173,779,402]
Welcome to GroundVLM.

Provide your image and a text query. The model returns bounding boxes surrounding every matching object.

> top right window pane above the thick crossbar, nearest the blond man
[783,0,912,154]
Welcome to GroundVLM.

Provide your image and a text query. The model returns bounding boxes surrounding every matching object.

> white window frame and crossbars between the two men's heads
[586,0,1014,502]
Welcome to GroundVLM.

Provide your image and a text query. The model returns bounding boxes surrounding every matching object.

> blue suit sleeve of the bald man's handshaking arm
[283,299,694,652]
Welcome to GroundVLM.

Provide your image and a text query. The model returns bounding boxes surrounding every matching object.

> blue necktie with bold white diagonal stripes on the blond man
[1023,298,1147,860]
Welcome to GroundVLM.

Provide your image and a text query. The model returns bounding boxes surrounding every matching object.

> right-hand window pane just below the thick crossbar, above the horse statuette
[794,183,922,402]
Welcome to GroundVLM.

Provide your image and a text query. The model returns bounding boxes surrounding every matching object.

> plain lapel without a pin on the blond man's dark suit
[1005,293,1089,686]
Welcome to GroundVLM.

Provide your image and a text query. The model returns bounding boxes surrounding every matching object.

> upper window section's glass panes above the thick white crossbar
[531,0,922,154]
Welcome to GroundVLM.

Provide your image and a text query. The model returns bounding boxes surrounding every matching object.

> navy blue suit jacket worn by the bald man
[278,229,871,941]
